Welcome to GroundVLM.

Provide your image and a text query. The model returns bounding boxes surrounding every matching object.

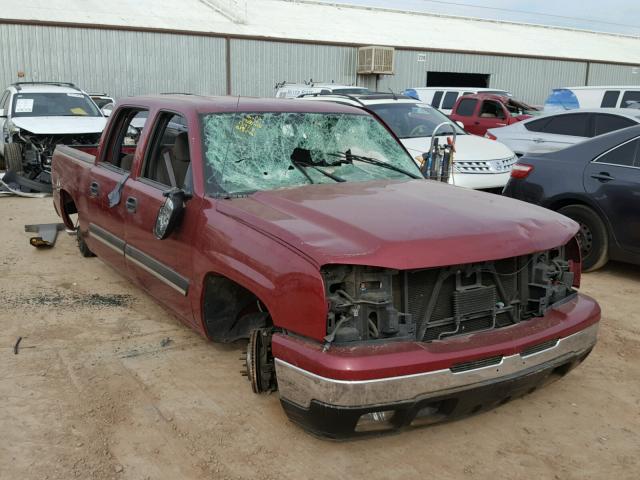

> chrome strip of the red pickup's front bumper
[275,324,598,408]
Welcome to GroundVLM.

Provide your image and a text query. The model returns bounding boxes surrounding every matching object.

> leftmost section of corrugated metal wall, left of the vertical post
[0,24,226,97]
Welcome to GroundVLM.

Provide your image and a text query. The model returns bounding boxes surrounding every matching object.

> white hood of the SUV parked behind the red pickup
[400,135,513,162]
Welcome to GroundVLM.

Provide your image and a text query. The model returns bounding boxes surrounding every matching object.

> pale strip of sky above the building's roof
[318,0,640,35]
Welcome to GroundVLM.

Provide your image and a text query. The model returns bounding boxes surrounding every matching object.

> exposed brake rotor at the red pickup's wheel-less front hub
[243,328,278,393]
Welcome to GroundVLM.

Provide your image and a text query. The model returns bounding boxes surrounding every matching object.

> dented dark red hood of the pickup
[216,180,578,269]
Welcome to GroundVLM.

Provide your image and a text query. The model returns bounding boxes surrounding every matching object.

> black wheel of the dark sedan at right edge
[558,205,609,272]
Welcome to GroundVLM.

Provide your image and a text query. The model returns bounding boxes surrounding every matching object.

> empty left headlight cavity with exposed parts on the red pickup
[321,265,415,343]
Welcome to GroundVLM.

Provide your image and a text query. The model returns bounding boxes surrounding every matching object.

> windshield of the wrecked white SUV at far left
[13,93,102,117]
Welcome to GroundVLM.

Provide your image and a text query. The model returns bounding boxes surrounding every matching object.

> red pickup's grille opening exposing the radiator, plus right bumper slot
[404,247,575,342]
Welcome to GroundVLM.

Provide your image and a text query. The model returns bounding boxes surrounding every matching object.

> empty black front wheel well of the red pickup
[202,273,271,343]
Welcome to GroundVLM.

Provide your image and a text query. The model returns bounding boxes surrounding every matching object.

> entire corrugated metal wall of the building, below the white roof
[0,24,640,104]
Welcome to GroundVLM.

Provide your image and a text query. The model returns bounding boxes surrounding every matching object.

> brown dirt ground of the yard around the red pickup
[0,198,640,480]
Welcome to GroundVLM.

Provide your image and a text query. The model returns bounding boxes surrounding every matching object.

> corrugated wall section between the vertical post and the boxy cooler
[231,39,357,97]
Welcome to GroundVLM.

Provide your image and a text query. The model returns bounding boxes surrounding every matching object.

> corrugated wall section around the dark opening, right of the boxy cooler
[378,51,587,104]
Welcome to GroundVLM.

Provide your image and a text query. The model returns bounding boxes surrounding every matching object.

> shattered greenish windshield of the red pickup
[203,112,420,196]
